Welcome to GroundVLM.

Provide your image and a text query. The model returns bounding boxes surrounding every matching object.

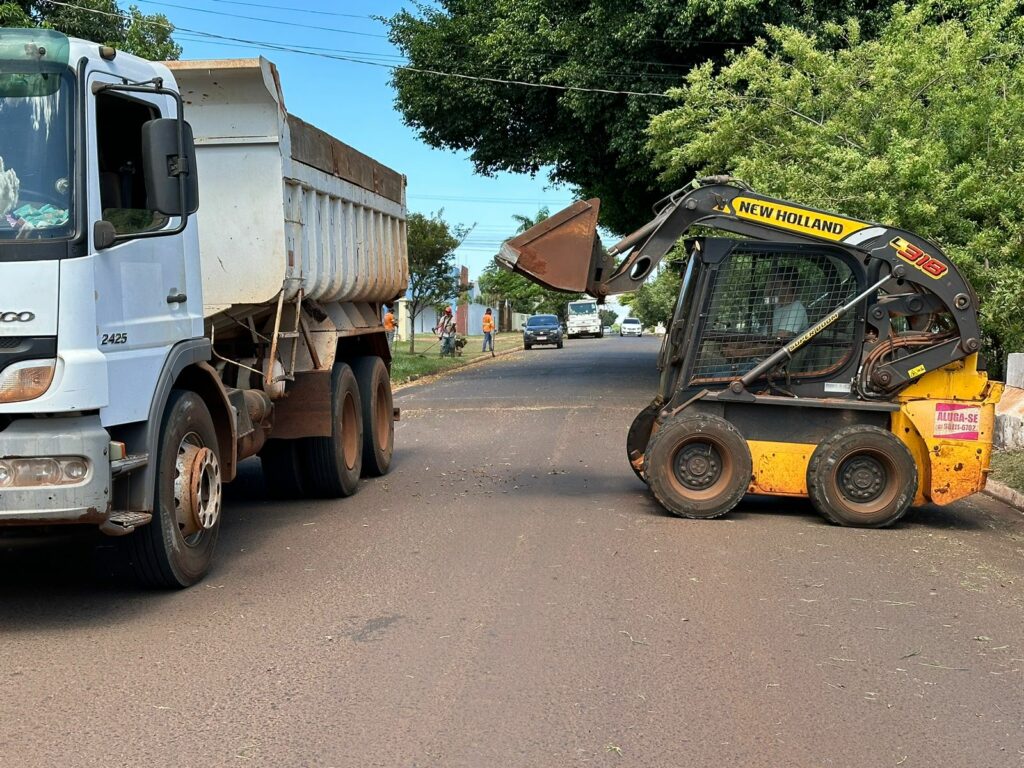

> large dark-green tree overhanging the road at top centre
[388,0,892,233]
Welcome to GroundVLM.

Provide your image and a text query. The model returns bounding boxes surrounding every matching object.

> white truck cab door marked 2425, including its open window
[86,72,194,376]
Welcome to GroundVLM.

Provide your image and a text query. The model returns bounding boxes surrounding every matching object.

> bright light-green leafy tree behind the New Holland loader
[649,1,1024,369]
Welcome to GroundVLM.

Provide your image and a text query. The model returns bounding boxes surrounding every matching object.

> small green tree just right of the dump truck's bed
[406,211,466,352]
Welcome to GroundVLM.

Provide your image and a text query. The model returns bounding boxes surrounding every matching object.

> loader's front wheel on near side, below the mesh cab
[644,415,753,518]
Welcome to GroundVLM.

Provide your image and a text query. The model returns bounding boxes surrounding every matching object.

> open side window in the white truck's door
[96,93,168,234]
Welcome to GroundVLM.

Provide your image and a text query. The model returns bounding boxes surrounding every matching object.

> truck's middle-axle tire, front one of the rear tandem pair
[301,362,362,499]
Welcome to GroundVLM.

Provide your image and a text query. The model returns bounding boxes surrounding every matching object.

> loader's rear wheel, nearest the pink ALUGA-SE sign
[807,426,918,528]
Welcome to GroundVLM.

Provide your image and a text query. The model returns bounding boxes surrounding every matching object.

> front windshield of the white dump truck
[0,71,74,242]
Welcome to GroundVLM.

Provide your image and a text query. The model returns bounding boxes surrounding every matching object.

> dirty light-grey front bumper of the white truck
[0,416,111,525]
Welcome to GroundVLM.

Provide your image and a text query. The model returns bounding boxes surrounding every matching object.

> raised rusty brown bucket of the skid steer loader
[495,198,607,296]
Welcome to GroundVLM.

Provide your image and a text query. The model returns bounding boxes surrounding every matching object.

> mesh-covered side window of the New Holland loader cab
[691,250,857,383]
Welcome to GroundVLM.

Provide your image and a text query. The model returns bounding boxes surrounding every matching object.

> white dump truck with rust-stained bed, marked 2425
[0,29,409,587]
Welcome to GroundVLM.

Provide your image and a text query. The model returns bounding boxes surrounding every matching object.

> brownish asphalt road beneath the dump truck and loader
[0,337,1024,768]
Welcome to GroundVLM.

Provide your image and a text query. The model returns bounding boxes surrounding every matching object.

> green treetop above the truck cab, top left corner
[0,0,181,61]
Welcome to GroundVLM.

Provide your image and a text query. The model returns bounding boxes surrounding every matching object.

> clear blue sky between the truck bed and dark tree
[135,0,573,279]
